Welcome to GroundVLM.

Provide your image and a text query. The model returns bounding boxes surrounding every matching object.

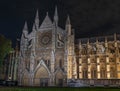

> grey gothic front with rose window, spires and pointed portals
[18,8,75,86]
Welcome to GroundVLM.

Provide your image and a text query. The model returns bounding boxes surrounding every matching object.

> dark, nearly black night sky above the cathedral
[0,0,120,47]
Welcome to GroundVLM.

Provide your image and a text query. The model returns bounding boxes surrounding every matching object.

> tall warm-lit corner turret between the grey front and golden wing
[65,16,76,79]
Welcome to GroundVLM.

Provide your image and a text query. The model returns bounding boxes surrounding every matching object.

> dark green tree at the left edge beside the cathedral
[0,35,13,79]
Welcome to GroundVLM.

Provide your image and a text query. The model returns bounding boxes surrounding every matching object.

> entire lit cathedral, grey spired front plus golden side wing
[18,8,120,86]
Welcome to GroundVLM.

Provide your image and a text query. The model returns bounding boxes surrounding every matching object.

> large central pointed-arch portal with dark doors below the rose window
[34,66,49,86]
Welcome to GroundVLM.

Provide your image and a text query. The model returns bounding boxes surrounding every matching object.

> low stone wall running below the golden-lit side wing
[67,79,120,87]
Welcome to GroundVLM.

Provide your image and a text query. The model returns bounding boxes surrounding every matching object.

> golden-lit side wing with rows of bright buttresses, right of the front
[76,34,120,79]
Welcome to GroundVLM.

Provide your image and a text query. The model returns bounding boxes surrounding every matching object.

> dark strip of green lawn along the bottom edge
[0,87,120,91]
